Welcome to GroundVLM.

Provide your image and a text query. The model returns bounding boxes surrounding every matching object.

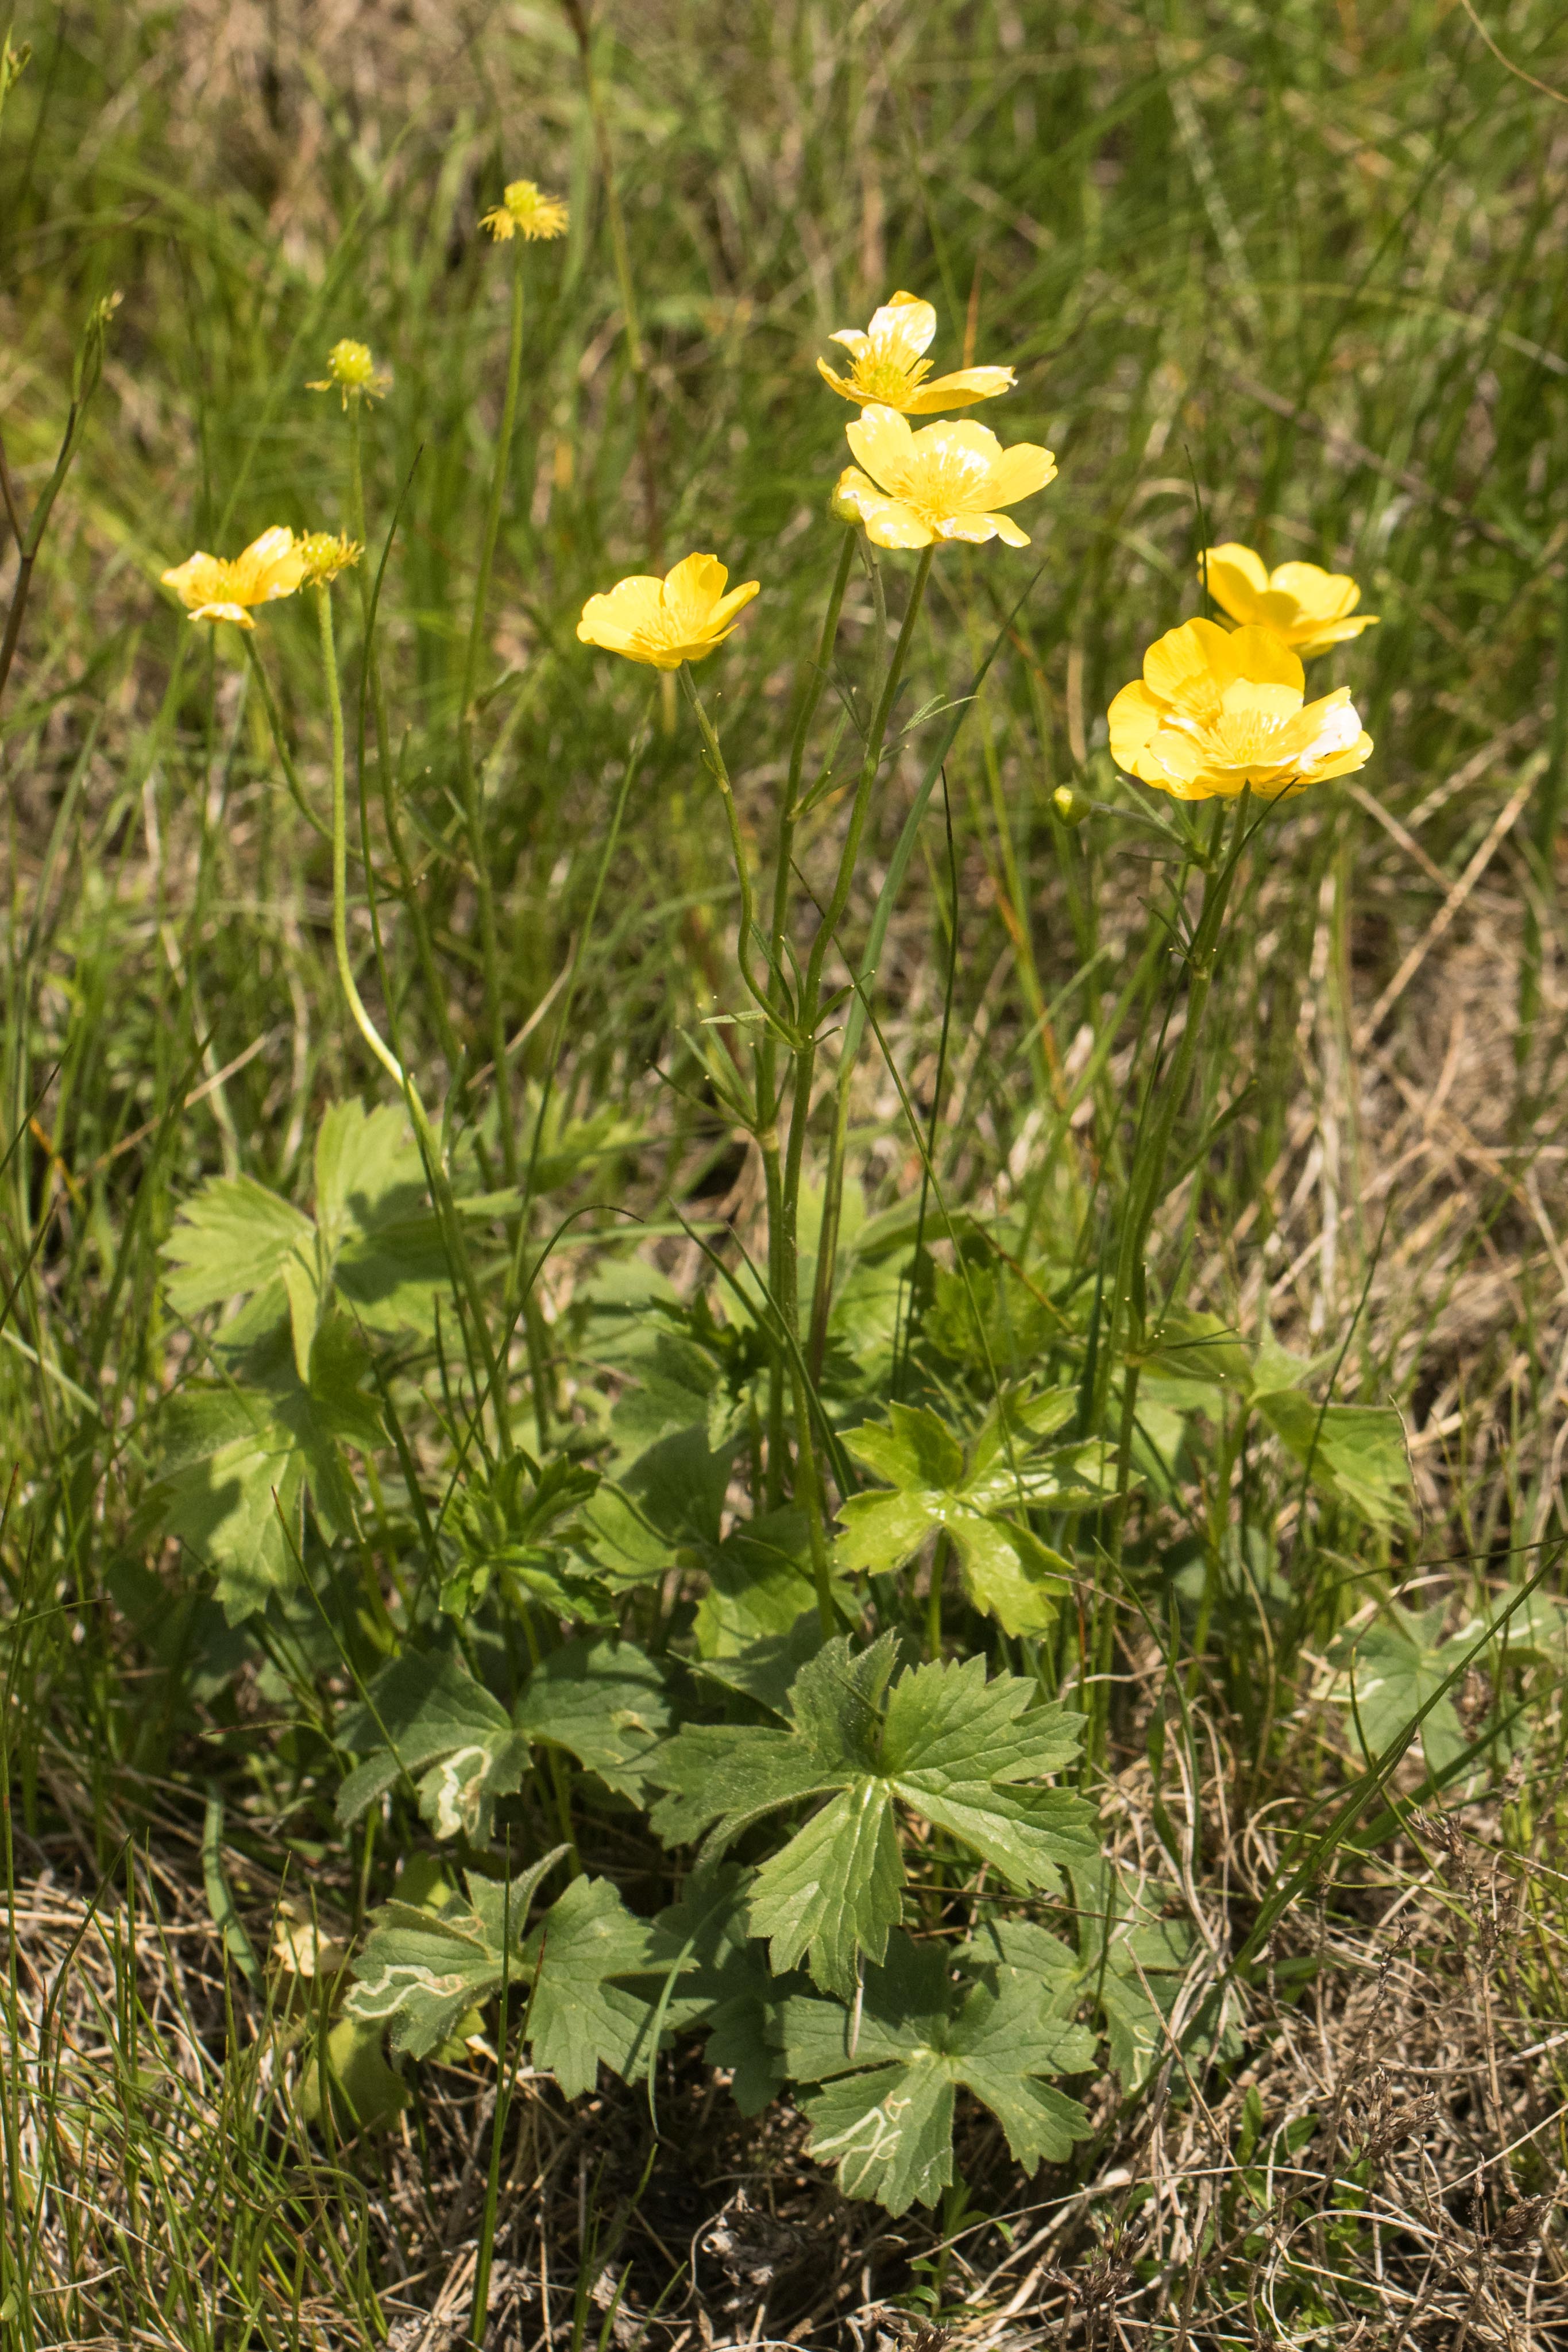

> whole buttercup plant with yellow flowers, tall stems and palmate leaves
[144,257,1401,2211]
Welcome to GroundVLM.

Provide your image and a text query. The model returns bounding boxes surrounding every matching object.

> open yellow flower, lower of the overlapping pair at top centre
[835,407,1056,548]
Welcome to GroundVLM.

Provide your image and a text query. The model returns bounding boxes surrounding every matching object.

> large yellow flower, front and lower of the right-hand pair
[1110,621,1373,800]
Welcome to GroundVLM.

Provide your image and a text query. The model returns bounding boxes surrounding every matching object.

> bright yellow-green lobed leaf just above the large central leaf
[837,1390,1107,1635]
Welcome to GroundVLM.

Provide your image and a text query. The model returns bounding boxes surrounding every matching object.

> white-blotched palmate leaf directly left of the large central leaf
[338,1642,670,1844]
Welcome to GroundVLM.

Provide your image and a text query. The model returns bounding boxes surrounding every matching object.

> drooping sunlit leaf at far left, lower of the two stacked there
[144,1315,383,1625]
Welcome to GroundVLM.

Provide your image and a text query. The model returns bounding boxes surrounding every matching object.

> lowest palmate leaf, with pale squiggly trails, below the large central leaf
[781,1931,1095,2213]
